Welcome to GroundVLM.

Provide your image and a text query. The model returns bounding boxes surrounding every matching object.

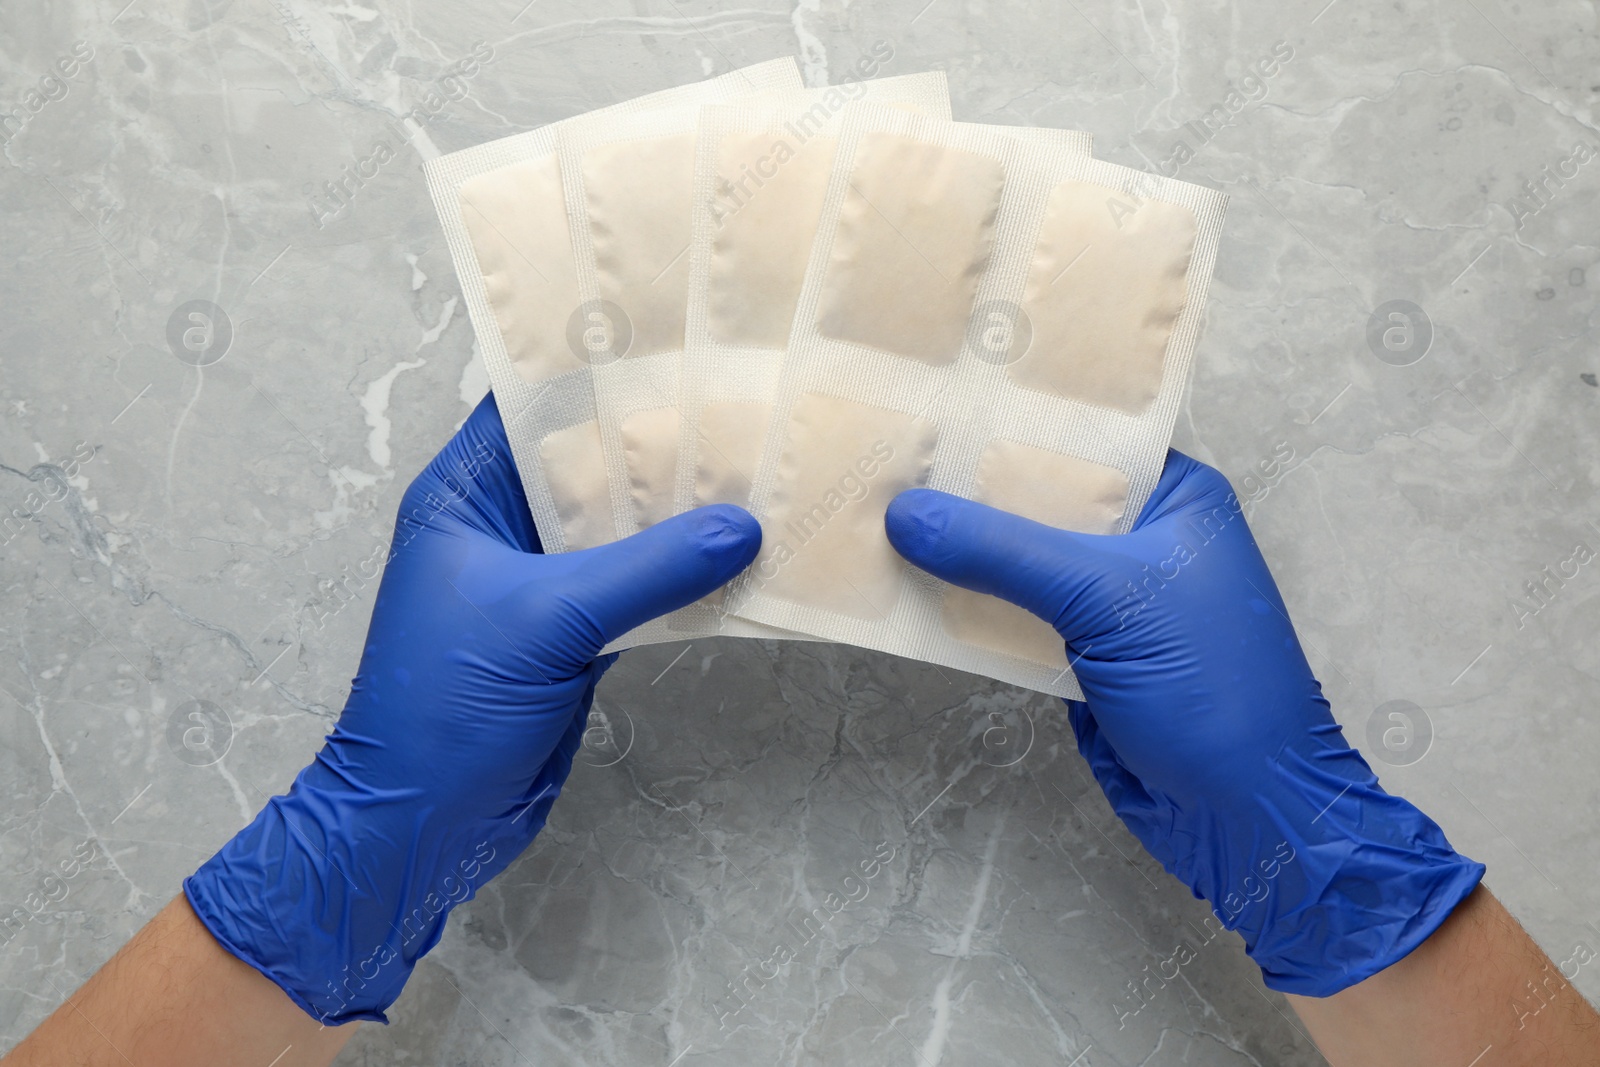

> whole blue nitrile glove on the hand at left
[184,398,760,1024]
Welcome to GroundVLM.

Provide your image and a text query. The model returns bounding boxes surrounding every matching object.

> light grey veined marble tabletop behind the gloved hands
[0,0,1600,1067]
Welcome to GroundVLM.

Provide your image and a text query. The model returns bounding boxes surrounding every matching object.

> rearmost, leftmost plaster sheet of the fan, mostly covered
[424,58,803,552]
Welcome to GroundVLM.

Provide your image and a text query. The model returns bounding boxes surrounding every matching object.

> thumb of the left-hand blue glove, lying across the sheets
[539,504,762,662]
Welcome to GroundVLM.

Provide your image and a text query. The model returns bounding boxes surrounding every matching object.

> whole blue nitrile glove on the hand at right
[886,451,1483,997]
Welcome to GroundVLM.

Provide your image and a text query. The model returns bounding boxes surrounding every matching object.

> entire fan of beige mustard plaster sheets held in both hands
[427,59,1226,697]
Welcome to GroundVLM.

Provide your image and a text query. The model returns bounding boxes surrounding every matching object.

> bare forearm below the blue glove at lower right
[1290,886,1600,1067]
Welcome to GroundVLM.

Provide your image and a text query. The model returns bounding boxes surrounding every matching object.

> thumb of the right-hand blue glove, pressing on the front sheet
[883,490,1109,643]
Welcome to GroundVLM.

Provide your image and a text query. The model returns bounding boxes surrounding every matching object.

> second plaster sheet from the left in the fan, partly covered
[558,72,950,648]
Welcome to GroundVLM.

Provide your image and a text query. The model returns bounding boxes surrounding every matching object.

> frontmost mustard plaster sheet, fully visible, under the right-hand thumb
[728,104,1226,697]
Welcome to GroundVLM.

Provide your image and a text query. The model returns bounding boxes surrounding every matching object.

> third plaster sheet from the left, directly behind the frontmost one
[674,103,1093,632]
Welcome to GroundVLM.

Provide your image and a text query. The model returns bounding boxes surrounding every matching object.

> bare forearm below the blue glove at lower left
[0,896,355,1067]
